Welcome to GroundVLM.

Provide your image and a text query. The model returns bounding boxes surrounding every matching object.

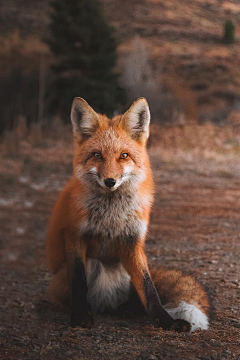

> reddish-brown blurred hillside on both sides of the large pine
[0,0,240,124]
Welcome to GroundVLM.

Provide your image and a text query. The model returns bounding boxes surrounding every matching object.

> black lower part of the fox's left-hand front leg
[71,258,92,327]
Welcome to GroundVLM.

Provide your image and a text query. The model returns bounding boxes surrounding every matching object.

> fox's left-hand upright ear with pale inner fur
[71,97,99,140]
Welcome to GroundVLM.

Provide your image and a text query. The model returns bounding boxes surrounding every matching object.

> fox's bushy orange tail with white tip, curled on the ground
[150,268,209,331]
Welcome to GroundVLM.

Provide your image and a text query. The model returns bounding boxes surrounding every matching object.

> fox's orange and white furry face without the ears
[74,121,150,193]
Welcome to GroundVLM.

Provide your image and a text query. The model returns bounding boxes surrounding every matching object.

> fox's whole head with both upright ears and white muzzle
[71,97,150,191]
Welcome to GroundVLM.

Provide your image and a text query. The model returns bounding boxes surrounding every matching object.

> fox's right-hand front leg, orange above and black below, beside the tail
[121,246,191,332]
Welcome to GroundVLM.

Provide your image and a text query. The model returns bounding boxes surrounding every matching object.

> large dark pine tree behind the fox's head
[46,0,125,116]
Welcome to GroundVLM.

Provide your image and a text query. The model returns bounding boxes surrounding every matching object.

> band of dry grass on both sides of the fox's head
[0,122,240,180]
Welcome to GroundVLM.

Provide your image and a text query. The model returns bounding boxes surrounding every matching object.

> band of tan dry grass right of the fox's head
[149,123,240,161]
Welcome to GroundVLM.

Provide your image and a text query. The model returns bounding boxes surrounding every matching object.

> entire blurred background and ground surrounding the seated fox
[0,0,240,360]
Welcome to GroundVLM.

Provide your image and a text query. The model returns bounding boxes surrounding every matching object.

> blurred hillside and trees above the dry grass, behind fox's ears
[0,0,240,134]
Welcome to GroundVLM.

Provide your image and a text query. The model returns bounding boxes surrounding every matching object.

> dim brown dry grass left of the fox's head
[0,119,73,176]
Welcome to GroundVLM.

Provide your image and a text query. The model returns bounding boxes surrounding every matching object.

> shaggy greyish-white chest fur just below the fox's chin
[79,187,147,241]
